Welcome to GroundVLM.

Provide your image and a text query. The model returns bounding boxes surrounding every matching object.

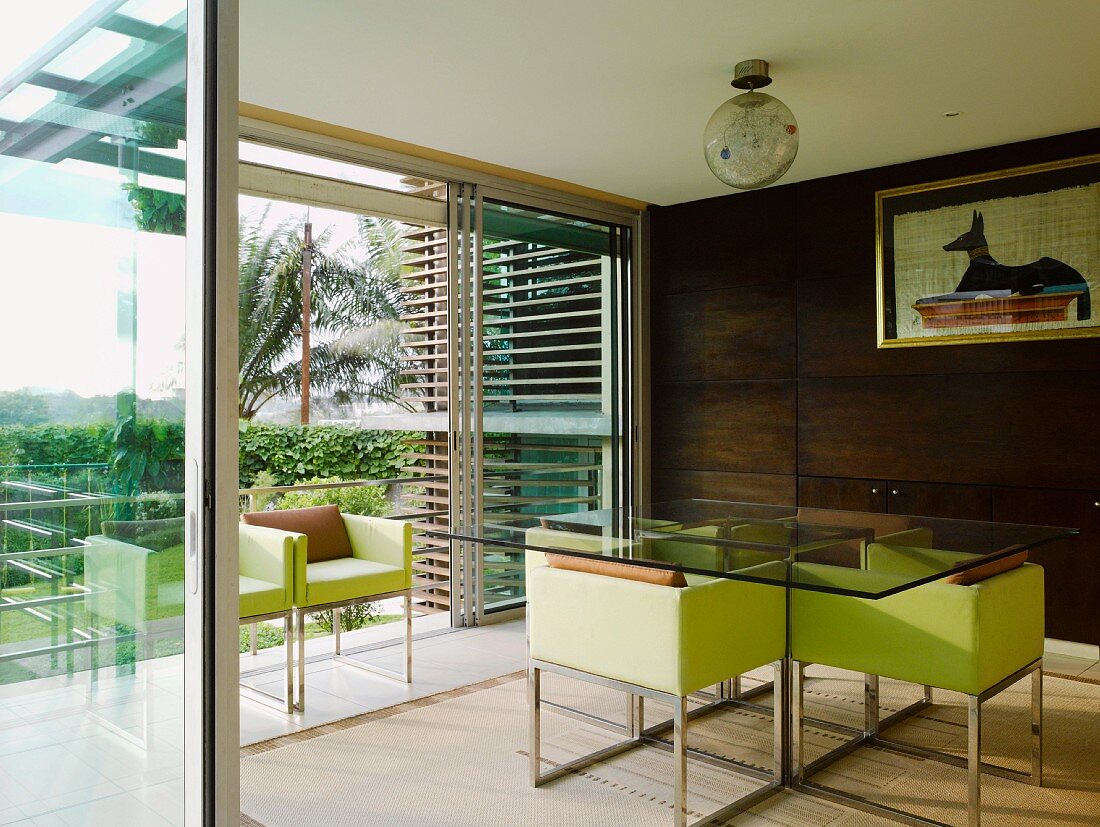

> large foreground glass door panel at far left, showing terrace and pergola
[0,0,235,825]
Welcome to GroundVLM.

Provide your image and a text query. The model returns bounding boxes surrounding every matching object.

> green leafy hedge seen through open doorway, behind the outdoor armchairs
[241,423,413,488]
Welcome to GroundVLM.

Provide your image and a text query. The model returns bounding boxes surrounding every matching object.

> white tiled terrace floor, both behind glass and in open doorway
[0,616,526,827]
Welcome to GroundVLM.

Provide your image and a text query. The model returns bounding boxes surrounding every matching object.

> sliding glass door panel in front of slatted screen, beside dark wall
[452,185,631,624]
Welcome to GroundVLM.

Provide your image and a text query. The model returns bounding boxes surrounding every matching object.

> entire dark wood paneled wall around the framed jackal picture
[650,130,1100,643]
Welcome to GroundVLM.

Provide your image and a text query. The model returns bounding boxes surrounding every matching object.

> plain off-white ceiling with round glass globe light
[240,0,1100,203]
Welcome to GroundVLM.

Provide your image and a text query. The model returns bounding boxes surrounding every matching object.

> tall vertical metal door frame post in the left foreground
[184,0,240,827]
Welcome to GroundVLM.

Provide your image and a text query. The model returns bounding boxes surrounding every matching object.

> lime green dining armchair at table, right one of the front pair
[791,543,1044,827]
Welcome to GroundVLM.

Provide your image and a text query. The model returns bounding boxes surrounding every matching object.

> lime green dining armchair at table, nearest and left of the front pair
[527,529,785,827]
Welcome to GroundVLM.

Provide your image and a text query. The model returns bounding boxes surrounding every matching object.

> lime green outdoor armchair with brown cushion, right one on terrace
[241,506,413,710]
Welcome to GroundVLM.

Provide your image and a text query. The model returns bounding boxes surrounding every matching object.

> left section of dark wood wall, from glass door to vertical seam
[650,187,798,505]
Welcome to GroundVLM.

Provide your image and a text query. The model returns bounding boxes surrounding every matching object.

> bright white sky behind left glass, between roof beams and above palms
[0,9,406,398]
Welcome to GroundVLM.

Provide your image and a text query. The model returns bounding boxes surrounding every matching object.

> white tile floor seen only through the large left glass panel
[0,657,184,827]
